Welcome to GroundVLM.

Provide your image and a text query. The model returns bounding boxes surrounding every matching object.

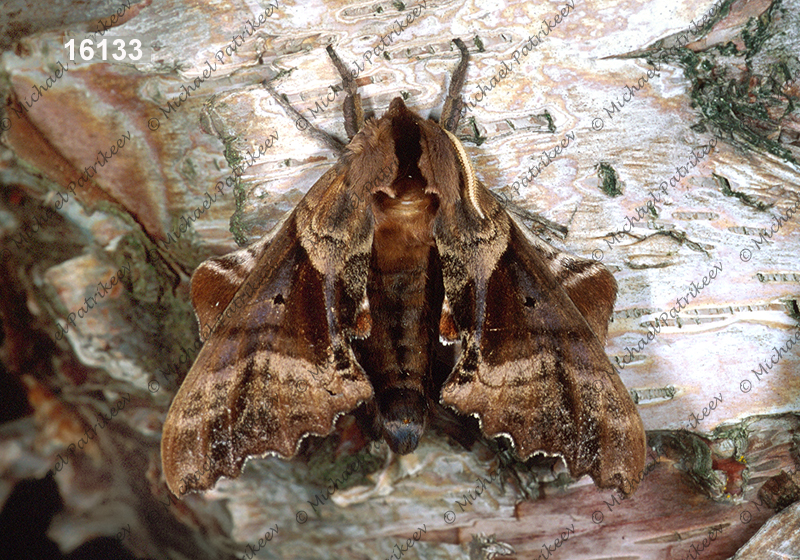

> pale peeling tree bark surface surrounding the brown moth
[0,0,800,560]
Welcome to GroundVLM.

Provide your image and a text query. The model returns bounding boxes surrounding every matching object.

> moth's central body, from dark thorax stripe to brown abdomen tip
[351,100,443,454]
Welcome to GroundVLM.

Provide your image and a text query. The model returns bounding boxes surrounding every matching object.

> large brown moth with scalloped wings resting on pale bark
[161,39,646,494]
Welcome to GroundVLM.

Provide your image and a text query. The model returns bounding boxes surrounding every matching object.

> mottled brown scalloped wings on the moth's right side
[435,137,646,492]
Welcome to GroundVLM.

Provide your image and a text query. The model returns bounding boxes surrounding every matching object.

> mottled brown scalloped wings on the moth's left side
[161,168,372,494]
